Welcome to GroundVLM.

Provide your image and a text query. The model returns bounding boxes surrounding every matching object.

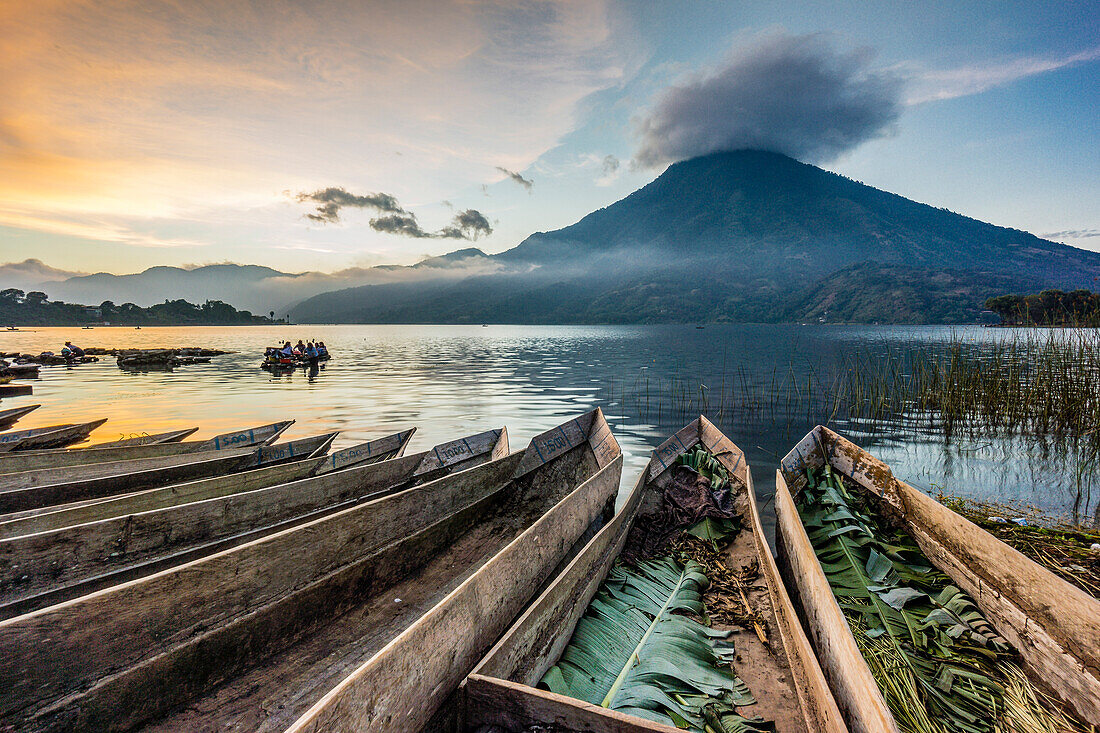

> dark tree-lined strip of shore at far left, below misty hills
[0,288,282,326]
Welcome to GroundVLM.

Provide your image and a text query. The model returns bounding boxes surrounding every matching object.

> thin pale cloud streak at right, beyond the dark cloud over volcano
[905,46,1100,106]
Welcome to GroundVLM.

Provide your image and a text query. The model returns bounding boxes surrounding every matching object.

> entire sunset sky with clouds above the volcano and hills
[0,0,1100,273]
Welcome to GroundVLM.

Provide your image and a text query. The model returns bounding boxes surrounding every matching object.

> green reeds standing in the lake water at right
[606,329,1100,444]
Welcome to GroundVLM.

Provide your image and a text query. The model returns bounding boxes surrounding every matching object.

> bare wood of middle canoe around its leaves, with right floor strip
[455,416,847,733]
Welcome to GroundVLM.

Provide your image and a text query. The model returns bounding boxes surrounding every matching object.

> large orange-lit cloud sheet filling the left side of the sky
[0,0,633,267]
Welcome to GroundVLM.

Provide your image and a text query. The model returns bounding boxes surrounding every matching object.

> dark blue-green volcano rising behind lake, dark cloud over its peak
[292,151,1100,324]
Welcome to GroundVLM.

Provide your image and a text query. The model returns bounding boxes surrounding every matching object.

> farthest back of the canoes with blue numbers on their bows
[0,420,294,473]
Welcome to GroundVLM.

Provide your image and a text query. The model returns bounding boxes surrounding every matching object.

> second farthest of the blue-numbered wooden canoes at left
[0,433,337,510]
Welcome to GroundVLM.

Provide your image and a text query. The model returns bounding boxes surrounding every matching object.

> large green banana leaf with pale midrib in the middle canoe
[541,558,770,733]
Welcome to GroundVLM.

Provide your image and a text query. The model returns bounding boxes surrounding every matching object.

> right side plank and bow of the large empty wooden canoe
[289,408,623,733]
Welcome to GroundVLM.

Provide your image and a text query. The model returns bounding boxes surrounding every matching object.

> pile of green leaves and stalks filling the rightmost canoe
[798,464,1078,733]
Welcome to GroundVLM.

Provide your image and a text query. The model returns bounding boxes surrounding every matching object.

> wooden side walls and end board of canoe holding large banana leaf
[450,417,846,733]
